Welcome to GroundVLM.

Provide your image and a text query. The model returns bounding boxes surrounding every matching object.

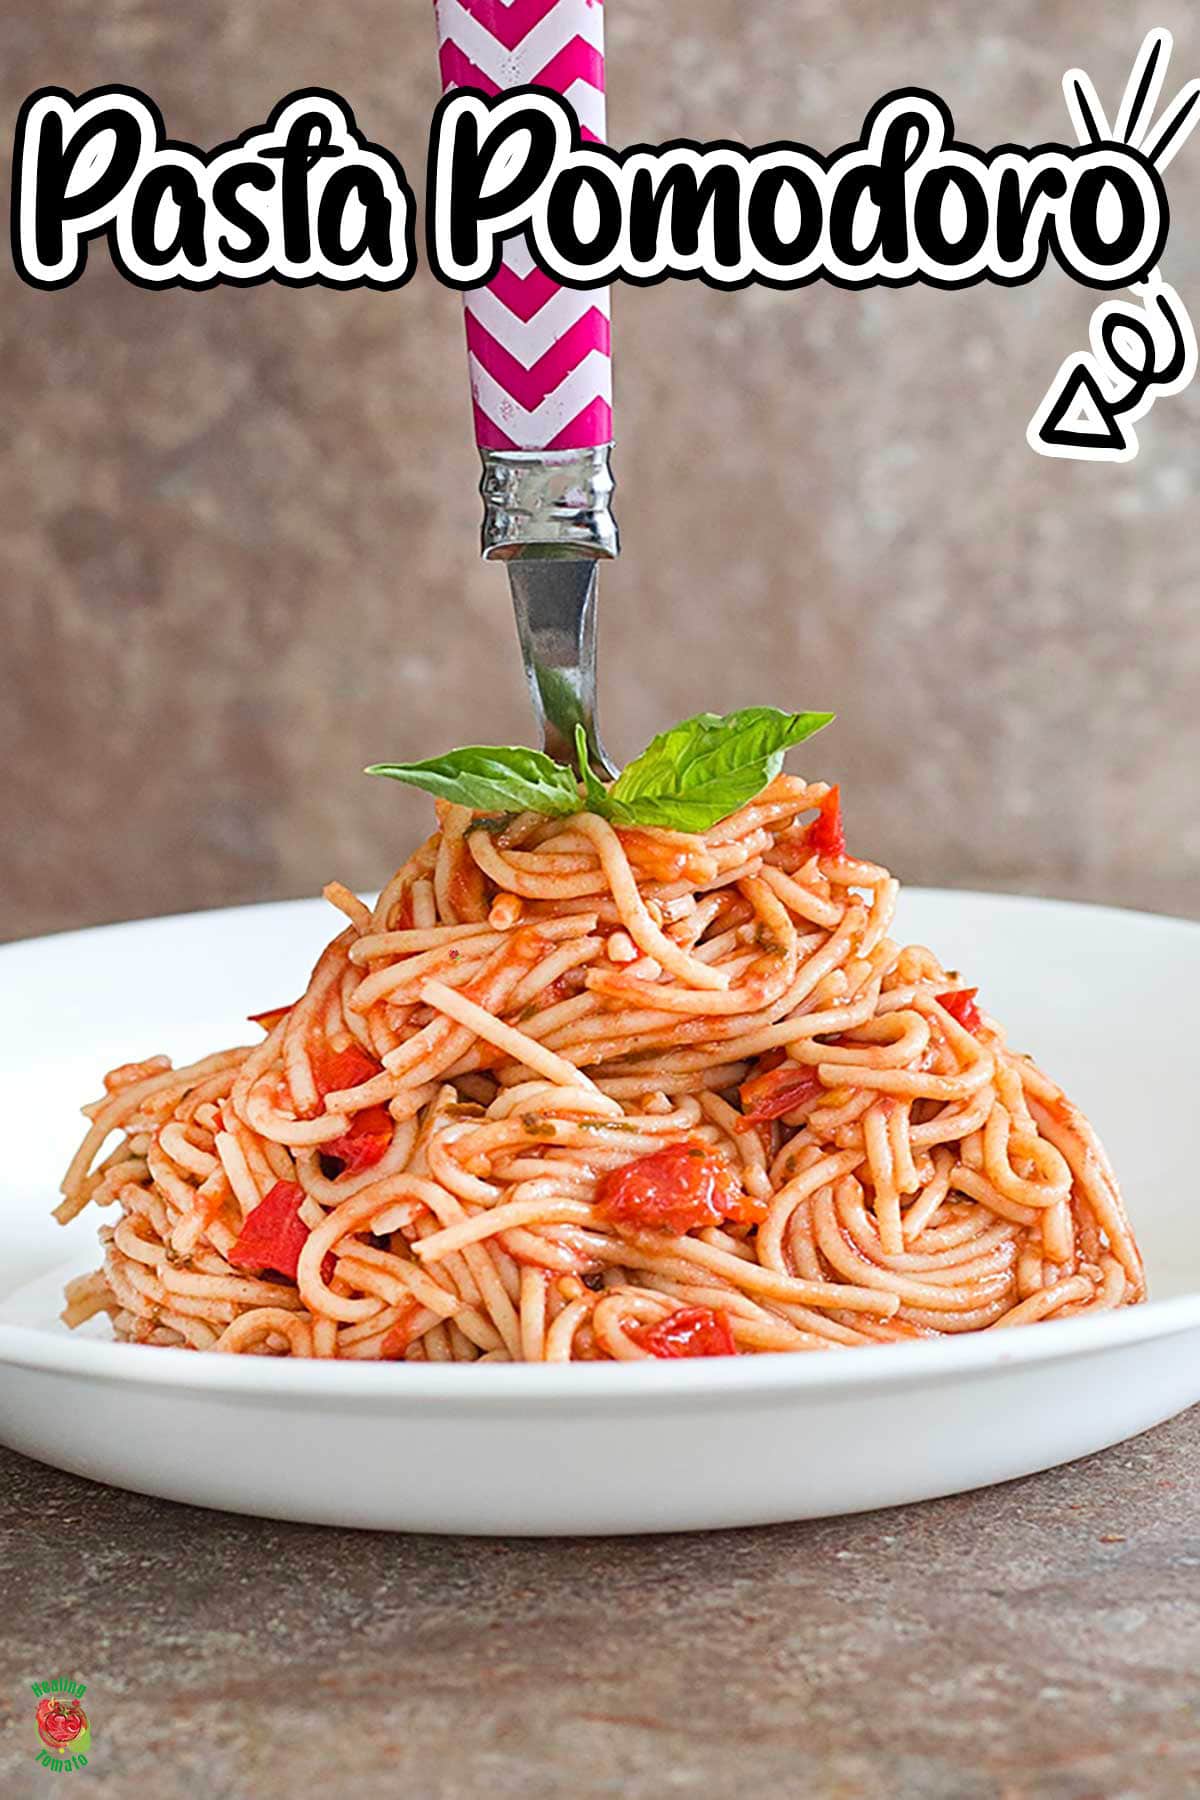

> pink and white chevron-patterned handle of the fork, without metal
[434,0,612,450]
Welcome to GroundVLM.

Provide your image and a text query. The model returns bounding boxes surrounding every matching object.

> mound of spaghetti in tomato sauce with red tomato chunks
[56,774,1144,1363]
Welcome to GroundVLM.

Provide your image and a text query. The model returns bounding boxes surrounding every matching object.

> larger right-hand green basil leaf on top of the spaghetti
[606,706,833,832]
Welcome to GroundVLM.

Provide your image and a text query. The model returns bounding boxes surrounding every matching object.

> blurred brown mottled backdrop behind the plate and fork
[0,0,1200,936]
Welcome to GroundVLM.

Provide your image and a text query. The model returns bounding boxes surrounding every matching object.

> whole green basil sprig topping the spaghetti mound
[367,706,833,832]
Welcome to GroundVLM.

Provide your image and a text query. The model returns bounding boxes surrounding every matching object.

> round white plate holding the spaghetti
[0,891,1200,1534]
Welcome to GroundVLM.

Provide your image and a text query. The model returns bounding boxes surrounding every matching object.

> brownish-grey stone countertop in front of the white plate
[0,1408,1200,1800]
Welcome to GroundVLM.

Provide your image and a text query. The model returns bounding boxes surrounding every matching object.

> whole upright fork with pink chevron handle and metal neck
[435,0,619,779]
